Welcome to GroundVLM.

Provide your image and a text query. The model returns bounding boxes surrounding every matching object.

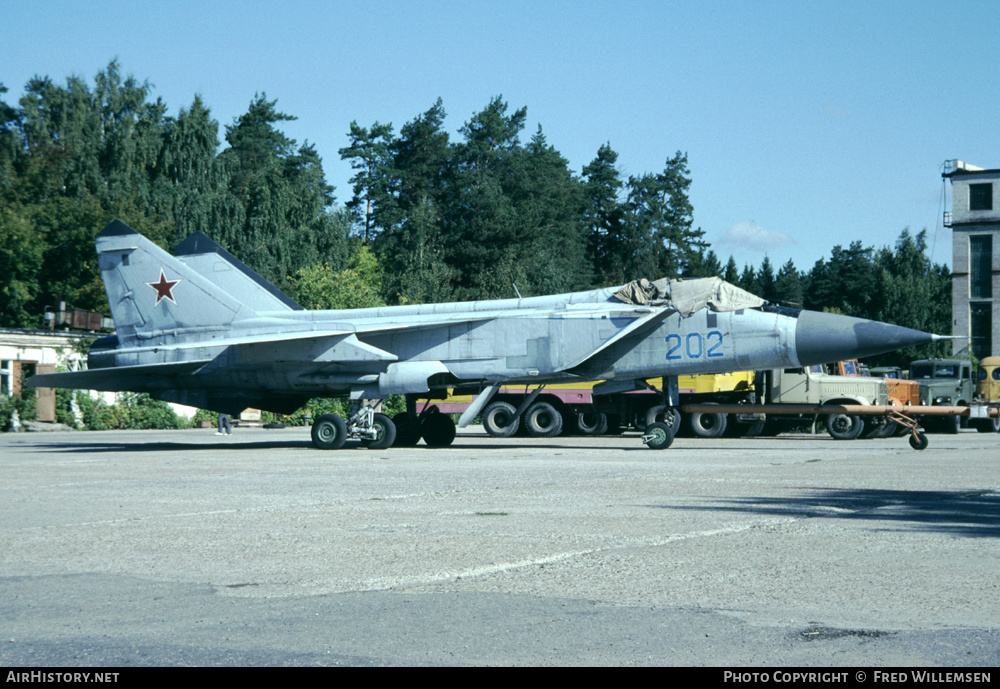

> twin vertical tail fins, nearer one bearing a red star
[96,220,301,344]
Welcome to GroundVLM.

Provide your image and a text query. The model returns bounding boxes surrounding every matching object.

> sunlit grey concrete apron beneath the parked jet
[0,427,1000,667]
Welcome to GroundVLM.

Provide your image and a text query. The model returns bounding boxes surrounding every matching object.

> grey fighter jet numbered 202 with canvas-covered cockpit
[29,220,939,449]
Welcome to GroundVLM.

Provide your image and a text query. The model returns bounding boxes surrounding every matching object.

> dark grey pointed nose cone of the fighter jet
[795,311,939,366]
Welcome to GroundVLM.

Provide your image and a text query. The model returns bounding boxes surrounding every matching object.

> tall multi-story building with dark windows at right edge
[943,160,1000,359]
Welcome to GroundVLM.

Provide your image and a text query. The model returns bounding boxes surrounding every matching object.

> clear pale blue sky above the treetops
[0,0,1000,270]
